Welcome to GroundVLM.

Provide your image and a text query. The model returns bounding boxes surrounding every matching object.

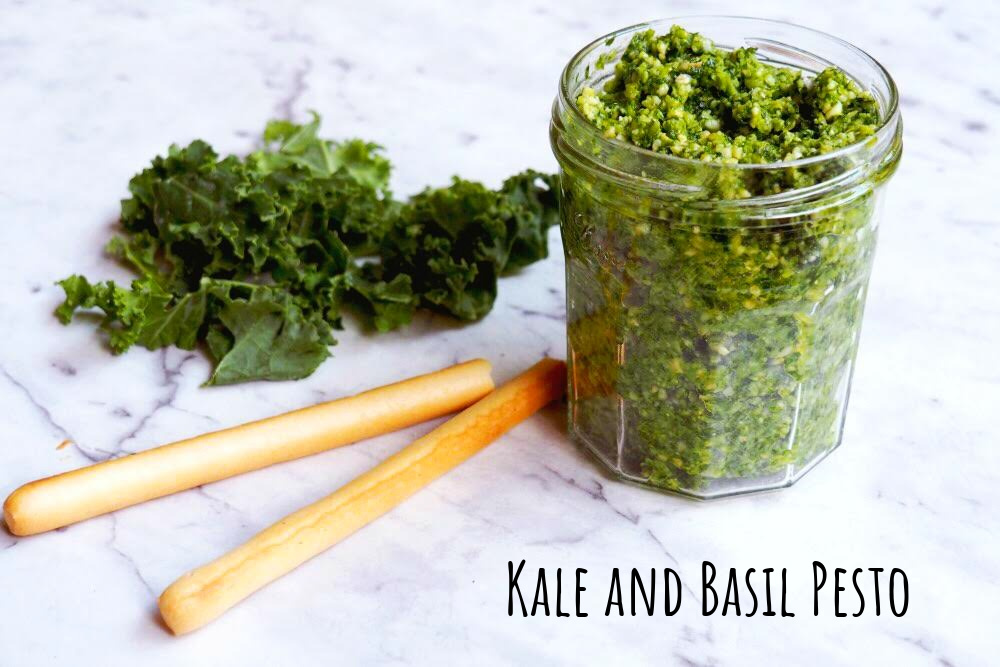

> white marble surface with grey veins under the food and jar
[0,0,1000,667]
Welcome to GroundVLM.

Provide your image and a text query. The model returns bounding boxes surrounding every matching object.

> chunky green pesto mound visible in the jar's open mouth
[576,25,879,164]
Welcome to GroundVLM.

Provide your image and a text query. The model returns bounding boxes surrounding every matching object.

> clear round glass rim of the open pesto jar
[557,14,900,172]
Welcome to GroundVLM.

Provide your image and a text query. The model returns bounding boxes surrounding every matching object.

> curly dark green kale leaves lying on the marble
[56,114,558,384]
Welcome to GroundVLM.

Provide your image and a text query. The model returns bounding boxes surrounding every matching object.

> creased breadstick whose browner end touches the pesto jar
[160,359,566,635]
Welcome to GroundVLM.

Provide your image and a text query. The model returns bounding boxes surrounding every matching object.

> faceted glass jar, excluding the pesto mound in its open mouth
[550,17,902,498]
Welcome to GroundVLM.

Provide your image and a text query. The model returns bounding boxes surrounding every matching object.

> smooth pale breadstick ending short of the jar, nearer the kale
[3,359,493,535]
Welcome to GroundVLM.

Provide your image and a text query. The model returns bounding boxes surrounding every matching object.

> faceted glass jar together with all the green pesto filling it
[550,17,902,498]
